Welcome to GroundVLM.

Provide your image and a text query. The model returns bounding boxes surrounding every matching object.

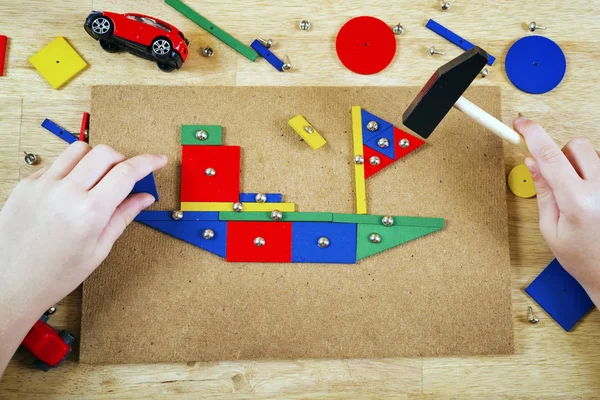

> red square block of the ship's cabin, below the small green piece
[181,146,240,203]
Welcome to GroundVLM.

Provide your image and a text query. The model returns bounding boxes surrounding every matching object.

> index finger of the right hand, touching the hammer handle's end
[514,118,581,198]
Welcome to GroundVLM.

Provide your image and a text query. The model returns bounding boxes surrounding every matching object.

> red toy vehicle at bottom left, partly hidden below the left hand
[21,313,75,372]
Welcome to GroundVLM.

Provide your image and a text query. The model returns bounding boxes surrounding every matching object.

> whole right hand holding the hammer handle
[514,118,600,307]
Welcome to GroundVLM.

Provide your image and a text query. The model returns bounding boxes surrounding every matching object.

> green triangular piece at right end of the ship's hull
[356,224,443,261]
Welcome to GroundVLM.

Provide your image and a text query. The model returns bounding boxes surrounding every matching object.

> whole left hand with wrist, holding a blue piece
[0,142,167,375]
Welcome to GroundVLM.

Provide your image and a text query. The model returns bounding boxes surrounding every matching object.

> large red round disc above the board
[335,17,396,75]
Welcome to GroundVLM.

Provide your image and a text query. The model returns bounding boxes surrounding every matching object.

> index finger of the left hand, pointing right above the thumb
[89,154,167,210]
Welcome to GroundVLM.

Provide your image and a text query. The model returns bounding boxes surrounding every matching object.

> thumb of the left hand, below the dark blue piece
[97,193,155,258]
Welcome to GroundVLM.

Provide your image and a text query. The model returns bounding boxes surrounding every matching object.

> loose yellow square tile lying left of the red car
[29,36,87,89]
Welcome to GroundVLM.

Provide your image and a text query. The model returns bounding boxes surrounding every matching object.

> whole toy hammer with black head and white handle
[402,46,526,150]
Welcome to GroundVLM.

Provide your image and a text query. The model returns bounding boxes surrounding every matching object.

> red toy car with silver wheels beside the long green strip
[83,11,189,72]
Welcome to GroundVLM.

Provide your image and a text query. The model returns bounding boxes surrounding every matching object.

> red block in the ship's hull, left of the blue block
[226,221,292,262]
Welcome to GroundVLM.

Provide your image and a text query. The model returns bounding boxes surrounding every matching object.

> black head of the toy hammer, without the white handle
[402,46,488,138]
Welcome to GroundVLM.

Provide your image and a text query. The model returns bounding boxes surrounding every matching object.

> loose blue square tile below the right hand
[525,259,594,331]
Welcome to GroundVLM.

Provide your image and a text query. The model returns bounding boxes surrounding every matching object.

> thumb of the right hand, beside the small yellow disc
[525,157,560,237]
